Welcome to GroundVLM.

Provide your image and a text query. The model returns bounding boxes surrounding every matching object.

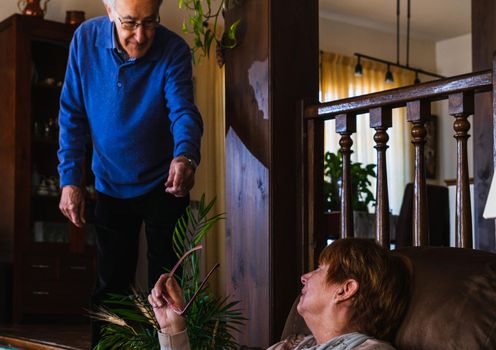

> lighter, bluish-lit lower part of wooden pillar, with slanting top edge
[226,128,270,347]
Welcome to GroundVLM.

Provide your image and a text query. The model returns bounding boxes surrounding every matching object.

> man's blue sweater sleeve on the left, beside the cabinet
[57,31,88,187]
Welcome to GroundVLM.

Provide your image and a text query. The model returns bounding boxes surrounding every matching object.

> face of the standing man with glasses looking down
[105,0,159,58]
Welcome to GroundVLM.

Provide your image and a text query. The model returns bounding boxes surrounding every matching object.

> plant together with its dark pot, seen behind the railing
[323,151,377,237]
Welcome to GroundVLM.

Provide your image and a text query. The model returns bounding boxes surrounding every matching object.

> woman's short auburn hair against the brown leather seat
[319,238,411,340]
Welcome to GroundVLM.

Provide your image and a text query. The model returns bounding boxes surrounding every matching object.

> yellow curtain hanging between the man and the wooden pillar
[191,55,226,292]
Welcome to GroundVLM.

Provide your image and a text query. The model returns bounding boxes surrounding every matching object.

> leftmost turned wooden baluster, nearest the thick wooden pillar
[336,114,356,238]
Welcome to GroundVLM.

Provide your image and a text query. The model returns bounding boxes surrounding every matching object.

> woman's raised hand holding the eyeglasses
[148,273,186,334]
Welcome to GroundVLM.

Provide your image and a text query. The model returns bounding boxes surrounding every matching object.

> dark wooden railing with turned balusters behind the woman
[302,65,494,265]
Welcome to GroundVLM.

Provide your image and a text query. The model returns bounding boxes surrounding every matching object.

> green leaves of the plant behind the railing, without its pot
[324,151,377,212]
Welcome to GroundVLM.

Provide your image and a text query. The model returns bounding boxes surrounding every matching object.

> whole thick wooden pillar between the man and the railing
[225,0,319,347]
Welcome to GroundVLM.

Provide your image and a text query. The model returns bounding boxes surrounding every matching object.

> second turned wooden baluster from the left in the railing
[370,107,392,248]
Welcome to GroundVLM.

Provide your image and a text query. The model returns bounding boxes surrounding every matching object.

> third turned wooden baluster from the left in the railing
[407,100,431,246]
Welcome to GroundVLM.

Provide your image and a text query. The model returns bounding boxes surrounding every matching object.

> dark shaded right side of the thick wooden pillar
[270,0,319,342]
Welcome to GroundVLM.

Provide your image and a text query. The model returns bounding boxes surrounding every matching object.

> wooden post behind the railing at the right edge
[472,0,496,251]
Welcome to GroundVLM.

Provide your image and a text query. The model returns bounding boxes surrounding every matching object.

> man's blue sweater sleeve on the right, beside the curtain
[164,41,203,164]
